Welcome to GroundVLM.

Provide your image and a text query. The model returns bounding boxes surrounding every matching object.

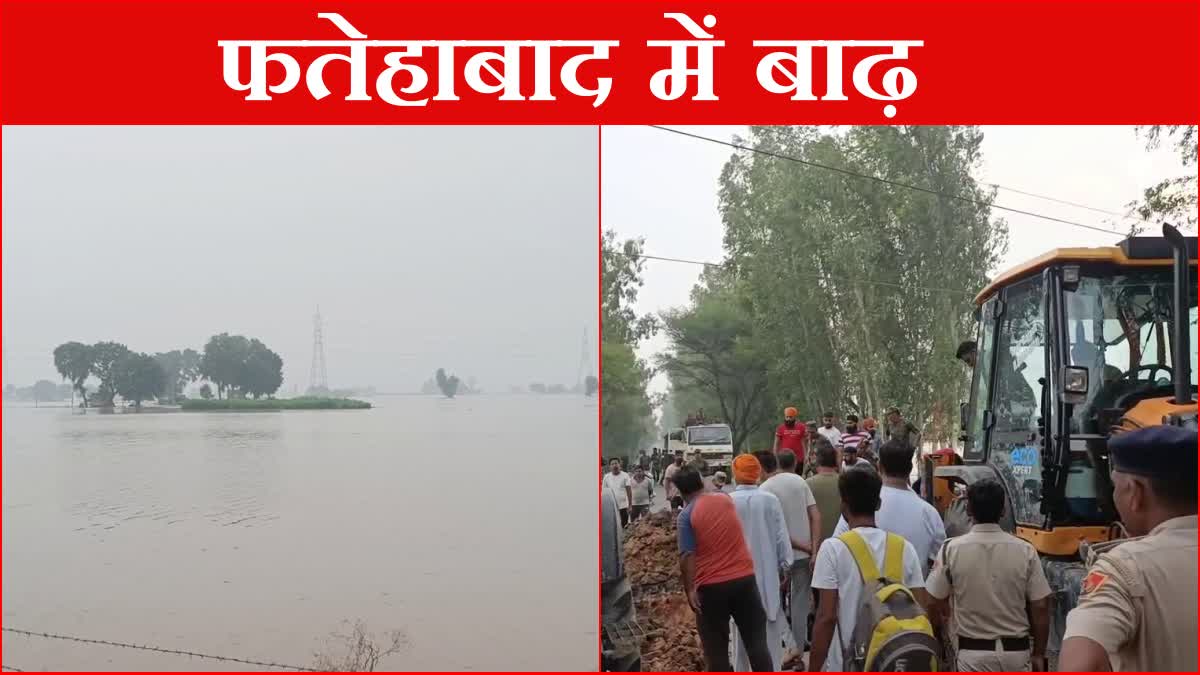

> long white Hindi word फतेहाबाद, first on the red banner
[217,12,619,107]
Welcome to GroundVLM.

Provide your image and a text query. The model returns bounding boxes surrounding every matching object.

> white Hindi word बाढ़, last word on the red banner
[754,40,924,118]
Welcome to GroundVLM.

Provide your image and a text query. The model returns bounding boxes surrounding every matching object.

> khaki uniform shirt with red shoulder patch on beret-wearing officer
[1063,514,1198,671]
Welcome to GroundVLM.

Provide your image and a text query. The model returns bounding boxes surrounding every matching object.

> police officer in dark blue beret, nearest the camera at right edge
[1058,425,1198,671]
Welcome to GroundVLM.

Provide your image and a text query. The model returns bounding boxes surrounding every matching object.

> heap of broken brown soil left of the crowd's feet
[625,512,704,673]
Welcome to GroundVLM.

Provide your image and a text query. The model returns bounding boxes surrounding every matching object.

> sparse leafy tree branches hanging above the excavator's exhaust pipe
[1129,125,1200,228]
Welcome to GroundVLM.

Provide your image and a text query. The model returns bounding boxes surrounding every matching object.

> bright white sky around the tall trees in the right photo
[601,126,1195,390]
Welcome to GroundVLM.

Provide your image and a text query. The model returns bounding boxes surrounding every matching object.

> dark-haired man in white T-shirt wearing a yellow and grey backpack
[809,467,940,671]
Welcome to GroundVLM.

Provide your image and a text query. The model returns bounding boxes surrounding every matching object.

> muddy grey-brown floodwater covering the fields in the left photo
[2,396,599,670]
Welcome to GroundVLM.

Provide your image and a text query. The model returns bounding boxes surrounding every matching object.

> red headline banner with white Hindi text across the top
[0,1,1200,124]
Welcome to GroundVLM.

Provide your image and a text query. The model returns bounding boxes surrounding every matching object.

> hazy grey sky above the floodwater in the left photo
[2,126,599,393]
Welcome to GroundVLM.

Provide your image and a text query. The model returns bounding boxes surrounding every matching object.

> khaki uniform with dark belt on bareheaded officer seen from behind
[925,524,1050,671]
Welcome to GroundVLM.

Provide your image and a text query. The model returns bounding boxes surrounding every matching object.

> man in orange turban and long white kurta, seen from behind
[732,454,792,673]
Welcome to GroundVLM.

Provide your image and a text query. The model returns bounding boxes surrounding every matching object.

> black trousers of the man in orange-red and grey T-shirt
[696,574,775,673]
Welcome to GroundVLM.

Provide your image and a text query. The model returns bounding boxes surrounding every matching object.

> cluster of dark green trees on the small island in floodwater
[54,333,283,407]
